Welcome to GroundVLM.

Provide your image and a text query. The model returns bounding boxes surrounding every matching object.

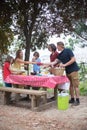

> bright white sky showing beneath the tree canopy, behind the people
[30,35,87,63]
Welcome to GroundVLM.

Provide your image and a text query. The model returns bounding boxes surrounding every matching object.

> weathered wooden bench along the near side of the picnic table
[0,87,47,110]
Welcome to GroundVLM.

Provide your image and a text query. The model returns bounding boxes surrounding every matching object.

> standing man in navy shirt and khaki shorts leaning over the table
[57,42,80,105]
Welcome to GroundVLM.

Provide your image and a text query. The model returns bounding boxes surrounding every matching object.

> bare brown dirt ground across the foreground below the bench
[0,93,87,130]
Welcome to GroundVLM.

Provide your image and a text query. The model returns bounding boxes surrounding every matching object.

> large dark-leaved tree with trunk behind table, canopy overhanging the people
[0,0,87,60]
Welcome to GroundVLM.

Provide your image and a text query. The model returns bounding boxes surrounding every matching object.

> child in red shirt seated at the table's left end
[3,55,14,87]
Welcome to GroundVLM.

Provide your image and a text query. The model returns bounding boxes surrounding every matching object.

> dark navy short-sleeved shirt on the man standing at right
[58,48,79,74]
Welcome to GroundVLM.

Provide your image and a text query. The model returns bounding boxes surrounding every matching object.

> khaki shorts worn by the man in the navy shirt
[67,71,79,87]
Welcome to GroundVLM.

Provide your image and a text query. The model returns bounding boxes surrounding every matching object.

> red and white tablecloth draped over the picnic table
[5,75,69,88]
